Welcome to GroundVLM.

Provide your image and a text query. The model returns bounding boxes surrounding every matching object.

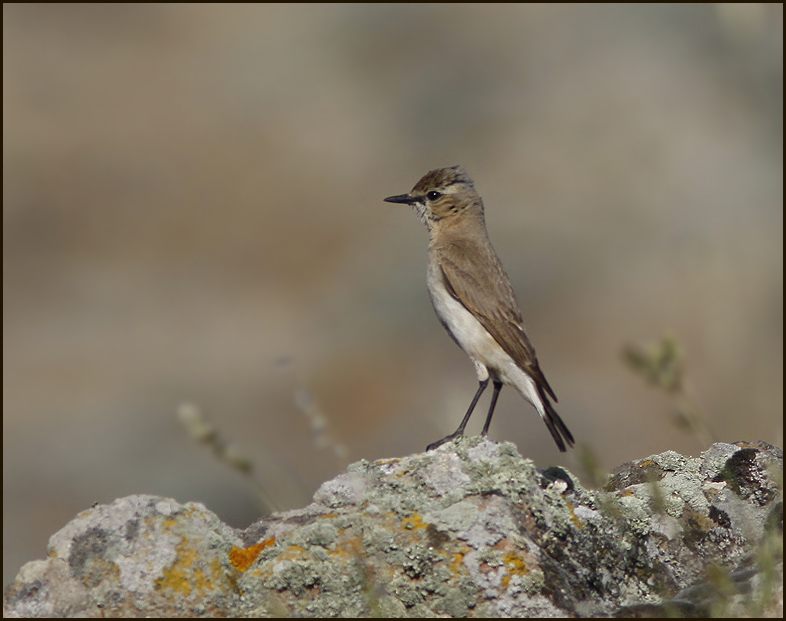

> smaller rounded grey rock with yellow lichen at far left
[4,495,240,617]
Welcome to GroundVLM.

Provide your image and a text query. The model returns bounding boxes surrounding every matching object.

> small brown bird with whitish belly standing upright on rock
[384,166,575,452]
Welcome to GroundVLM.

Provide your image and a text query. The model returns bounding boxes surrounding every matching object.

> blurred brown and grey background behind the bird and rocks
[3,3,783,584]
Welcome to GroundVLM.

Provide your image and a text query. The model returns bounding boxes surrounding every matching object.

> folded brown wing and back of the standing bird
[434,239,557,401]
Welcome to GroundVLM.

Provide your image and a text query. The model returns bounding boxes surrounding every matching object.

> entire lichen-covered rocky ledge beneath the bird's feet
[4,438,783,617]
